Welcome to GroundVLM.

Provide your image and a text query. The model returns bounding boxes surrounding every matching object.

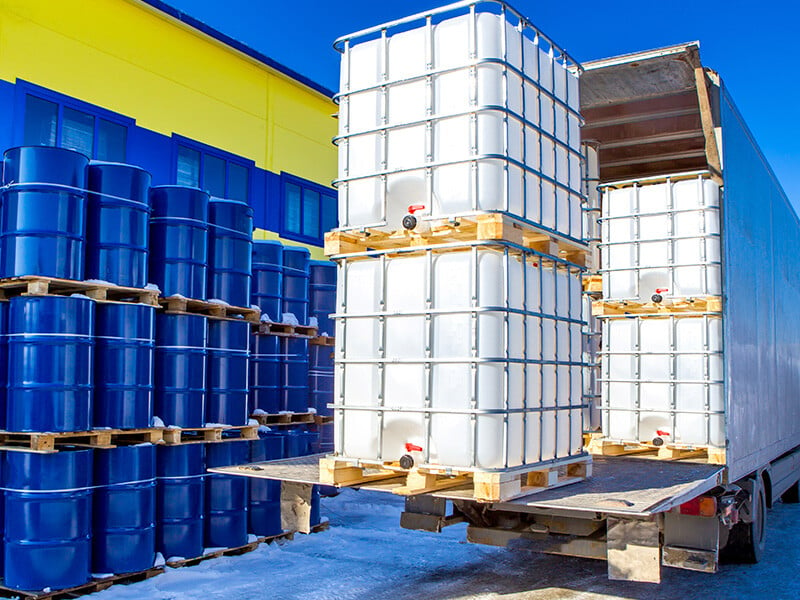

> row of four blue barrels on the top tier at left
[0,146,253,306]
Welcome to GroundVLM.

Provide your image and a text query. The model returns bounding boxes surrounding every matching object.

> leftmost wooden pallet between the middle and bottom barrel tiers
[0,427,162,453]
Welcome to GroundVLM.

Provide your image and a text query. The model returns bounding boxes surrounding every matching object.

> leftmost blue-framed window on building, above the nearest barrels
[22,92,128,162]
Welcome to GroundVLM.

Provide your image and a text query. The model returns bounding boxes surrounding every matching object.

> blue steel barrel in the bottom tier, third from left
[156,444,206,560]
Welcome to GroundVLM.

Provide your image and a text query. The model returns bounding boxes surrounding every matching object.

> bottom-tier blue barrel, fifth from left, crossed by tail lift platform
[248,432,284,536]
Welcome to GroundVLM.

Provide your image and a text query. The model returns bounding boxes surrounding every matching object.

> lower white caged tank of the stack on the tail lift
[328,245,584,469]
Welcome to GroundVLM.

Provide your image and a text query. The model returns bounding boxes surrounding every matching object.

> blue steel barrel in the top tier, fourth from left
[208,198,253,306]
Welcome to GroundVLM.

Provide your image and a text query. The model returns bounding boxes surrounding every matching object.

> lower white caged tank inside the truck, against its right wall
[602,316,725,447]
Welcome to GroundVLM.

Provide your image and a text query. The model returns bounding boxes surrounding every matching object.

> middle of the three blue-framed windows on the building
[174,136,255,202]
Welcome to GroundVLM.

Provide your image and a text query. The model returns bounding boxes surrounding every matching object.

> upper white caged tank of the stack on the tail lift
[337,2,583,239]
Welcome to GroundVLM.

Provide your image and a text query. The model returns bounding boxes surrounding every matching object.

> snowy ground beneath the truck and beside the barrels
[94,490,800,600]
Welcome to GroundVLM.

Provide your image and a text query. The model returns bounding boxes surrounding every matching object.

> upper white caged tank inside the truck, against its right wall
[601,174,722,302]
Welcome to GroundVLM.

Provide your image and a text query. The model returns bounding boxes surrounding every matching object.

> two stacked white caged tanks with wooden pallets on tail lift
[320,2,591,500]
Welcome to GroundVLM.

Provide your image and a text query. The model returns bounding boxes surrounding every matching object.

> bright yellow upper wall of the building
[0,0,336,190]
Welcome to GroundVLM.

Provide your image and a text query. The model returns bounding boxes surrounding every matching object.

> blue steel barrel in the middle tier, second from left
[94,302,156,429]
